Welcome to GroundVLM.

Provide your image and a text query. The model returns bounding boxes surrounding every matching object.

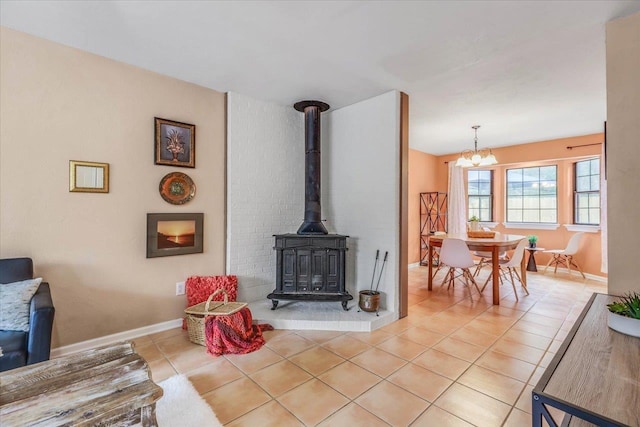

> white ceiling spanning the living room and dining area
[0,0,640,154]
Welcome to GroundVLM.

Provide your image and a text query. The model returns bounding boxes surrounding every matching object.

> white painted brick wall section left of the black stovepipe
[227,93,304,301]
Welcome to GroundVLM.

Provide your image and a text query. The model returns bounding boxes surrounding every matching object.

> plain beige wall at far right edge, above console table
[607,13,640,295]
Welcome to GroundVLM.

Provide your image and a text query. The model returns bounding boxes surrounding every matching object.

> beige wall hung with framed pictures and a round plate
[0,28,225,347]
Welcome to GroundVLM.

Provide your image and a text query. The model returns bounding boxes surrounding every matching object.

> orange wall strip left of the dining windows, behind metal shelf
[408,150,446,264]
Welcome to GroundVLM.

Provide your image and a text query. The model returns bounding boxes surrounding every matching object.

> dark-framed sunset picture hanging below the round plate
[147,213,204,258]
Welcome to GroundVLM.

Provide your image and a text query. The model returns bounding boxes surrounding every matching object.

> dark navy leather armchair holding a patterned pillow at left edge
[0,258,55,372]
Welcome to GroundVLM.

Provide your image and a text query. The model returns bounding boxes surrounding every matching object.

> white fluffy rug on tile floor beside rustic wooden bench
[156,375,222,427]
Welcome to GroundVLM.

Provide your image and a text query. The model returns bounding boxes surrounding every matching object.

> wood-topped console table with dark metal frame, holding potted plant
[532,294,640,427]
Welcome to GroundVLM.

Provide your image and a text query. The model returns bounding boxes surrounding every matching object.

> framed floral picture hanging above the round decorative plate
[155,117,196,168]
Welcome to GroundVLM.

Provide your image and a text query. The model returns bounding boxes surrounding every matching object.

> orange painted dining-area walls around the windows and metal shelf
[409,133,607,277]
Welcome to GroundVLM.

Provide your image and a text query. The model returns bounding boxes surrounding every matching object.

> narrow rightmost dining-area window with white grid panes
[573,158,600,225]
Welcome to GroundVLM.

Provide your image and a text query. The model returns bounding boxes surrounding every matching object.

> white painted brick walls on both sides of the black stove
[227,91,399,311]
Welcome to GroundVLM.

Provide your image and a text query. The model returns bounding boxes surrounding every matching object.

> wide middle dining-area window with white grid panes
[507,165,558,224]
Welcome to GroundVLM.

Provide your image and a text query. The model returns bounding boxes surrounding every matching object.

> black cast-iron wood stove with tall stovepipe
[267,101,353,310]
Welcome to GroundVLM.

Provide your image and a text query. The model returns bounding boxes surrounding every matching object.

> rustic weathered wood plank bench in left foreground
[0,342,162,427]
